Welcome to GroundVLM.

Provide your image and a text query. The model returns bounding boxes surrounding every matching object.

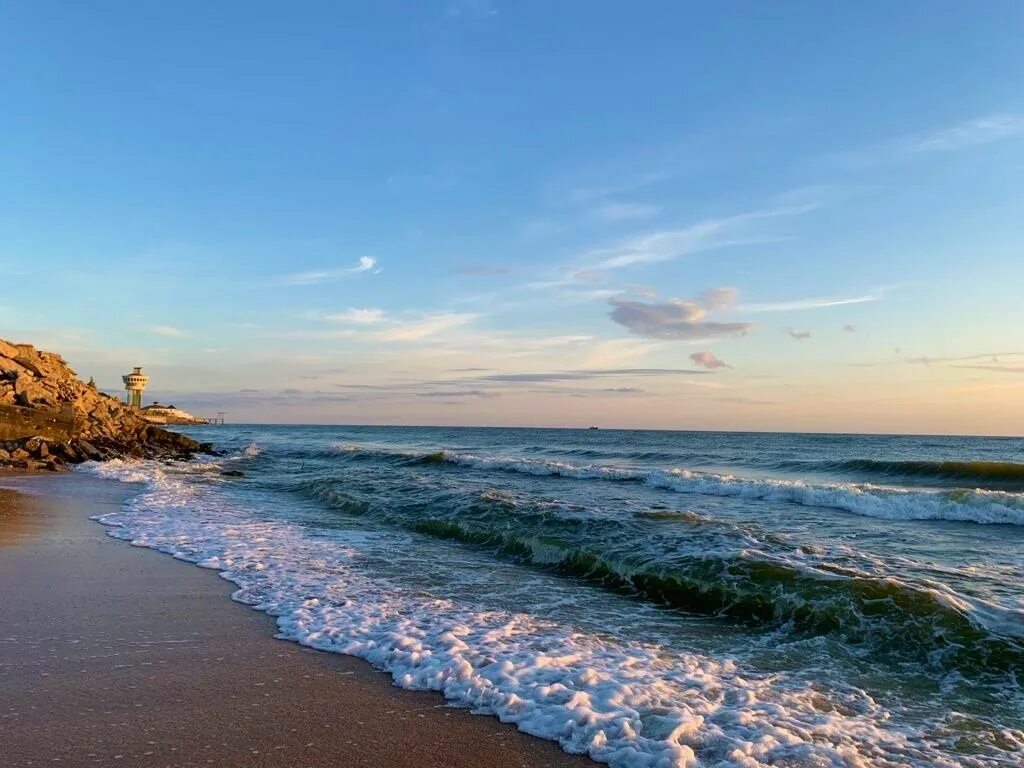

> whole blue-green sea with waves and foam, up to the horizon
[82,425,1024,768]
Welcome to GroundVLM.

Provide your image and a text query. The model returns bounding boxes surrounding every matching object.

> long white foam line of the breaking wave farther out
[444,452,1024,525]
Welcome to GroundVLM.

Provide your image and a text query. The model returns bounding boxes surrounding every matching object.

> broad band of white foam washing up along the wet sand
[77,462,1024,768]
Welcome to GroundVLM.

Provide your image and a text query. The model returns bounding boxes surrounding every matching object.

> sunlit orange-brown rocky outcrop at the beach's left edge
[0,339,211,470]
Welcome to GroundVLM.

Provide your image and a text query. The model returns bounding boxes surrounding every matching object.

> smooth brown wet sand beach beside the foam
[0,475,595,768]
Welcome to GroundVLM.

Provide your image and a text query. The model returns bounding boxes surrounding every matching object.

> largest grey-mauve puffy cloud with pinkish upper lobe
[608,288,754,341]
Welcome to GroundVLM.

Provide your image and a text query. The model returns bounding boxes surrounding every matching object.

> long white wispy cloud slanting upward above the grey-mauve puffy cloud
[583,203,817,269]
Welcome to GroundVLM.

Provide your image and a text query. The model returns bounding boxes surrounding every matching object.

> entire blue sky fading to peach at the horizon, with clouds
[0,0,1024,435]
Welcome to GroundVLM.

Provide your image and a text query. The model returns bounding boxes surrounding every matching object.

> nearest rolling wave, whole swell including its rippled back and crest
[296,479,1024,672]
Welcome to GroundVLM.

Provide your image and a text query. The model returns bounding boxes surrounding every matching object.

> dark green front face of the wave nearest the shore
[409,518,1024,671]
